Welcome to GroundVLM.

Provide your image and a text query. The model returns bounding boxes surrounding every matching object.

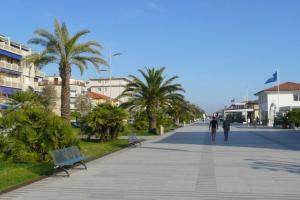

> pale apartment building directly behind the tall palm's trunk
[40,75,86,115]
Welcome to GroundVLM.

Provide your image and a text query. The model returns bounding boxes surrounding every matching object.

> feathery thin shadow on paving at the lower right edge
[245,159,300,174]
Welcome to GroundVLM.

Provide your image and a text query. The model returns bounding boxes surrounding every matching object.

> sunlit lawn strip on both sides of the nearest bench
[0,140,128,192]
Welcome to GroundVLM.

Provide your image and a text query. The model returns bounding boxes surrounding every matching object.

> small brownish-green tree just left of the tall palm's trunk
[38,85,57,111]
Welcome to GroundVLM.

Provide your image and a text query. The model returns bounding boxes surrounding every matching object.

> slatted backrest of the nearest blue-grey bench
[51,146,81,165]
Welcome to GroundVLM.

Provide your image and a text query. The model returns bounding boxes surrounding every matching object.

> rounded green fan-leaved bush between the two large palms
[86,104,128,142]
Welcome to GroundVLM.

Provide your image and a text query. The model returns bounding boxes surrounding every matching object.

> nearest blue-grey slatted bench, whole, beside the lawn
[51,146,87,176]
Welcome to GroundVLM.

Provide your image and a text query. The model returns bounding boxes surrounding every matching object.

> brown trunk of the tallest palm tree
[60,65,71,123]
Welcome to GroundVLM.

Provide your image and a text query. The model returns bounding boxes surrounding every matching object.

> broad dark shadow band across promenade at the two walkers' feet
[156,130,300,151]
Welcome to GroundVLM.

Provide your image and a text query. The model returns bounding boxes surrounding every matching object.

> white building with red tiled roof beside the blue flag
[255,82,300,126]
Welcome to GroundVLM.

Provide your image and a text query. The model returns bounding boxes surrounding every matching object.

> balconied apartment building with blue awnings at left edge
[0,35,45,95]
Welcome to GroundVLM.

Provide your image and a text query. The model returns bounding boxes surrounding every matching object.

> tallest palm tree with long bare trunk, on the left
[25,20,106,122]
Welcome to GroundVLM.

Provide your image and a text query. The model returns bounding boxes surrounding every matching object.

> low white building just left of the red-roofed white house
[223,101,259,123]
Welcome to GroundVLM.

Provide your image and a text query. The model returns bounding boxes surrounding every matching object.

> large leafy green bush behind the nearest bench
[0,104,79,162]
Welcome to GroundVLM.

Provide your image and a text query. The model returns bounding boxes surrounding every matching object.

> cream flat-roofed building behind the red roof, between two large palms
[87,77,130,102]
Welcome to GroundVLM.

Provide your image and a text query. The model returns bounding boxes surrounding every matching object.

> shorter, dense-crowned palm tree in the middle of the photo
[120,67,184,133]
